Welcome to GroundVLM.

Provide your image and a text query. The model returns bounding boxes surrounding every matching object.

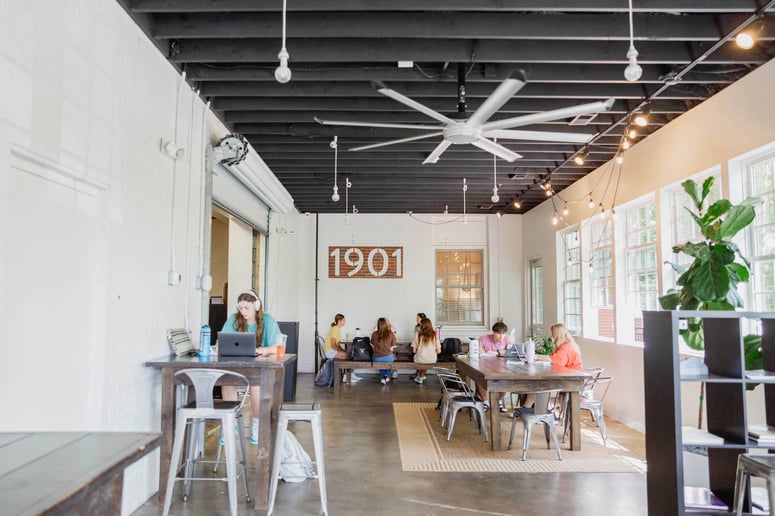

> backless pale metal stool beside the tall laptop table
[267,403,328,516]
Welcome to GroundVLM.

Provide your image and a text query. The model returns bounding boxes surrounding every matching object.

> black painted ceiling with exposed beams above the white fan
[117,0,775,213]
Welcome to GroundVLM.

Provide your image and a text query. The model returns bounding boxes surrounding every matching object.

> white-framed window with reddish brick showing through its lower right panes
[584,217,616,340]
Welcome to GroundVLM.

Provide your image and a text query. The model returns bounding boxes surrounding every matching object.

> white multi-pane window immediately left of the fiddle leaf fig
[617,196,659,343]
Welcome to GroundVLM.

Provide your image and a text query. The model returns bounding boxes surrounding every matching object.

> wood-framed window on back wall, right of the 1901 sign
[436,250,484,325]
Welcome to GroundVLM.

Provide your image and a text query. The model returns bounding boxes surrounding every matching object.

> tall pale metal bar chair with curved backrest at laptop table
[163,368,250,516]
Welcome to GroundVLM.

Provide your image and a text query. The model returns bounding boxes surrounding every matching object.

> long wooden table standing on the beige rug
[455,356,591,450]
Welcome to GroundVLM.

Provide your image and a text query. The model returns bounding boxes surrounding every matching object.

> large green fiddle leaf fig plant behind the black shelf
[659,176,760,352]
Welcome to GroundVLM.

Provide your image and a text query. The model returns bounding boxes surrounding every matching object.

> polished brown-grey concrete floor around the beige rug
[134,374,646,516]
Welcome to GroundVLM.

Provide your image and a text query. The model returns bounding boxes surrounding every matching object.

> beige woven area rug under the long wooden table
[393,403,646,473]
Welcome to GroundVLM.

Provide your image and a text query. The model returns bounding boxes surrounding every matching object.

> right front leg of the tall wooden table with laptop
[253,367,285,514]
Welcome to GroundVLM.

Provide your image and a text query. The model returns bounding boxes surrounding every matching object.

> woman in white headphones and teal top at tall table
[221,290,280,444]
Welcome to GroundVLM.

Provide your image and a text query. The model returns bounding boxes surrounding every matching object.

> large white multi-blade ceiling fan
[315,74,614,165]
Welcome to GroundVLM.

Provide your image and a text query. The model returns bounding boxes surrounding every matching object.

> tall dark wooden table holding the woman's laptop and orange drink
[145,353,296,514]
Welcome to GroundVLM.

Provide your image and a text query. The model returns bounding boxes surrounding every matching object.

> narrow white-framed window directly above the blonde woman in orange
[557,228,582,335]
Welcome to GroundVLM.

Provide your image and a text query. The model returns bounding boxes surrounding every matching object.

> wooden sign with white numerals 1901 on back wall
[328,246,404,278]
